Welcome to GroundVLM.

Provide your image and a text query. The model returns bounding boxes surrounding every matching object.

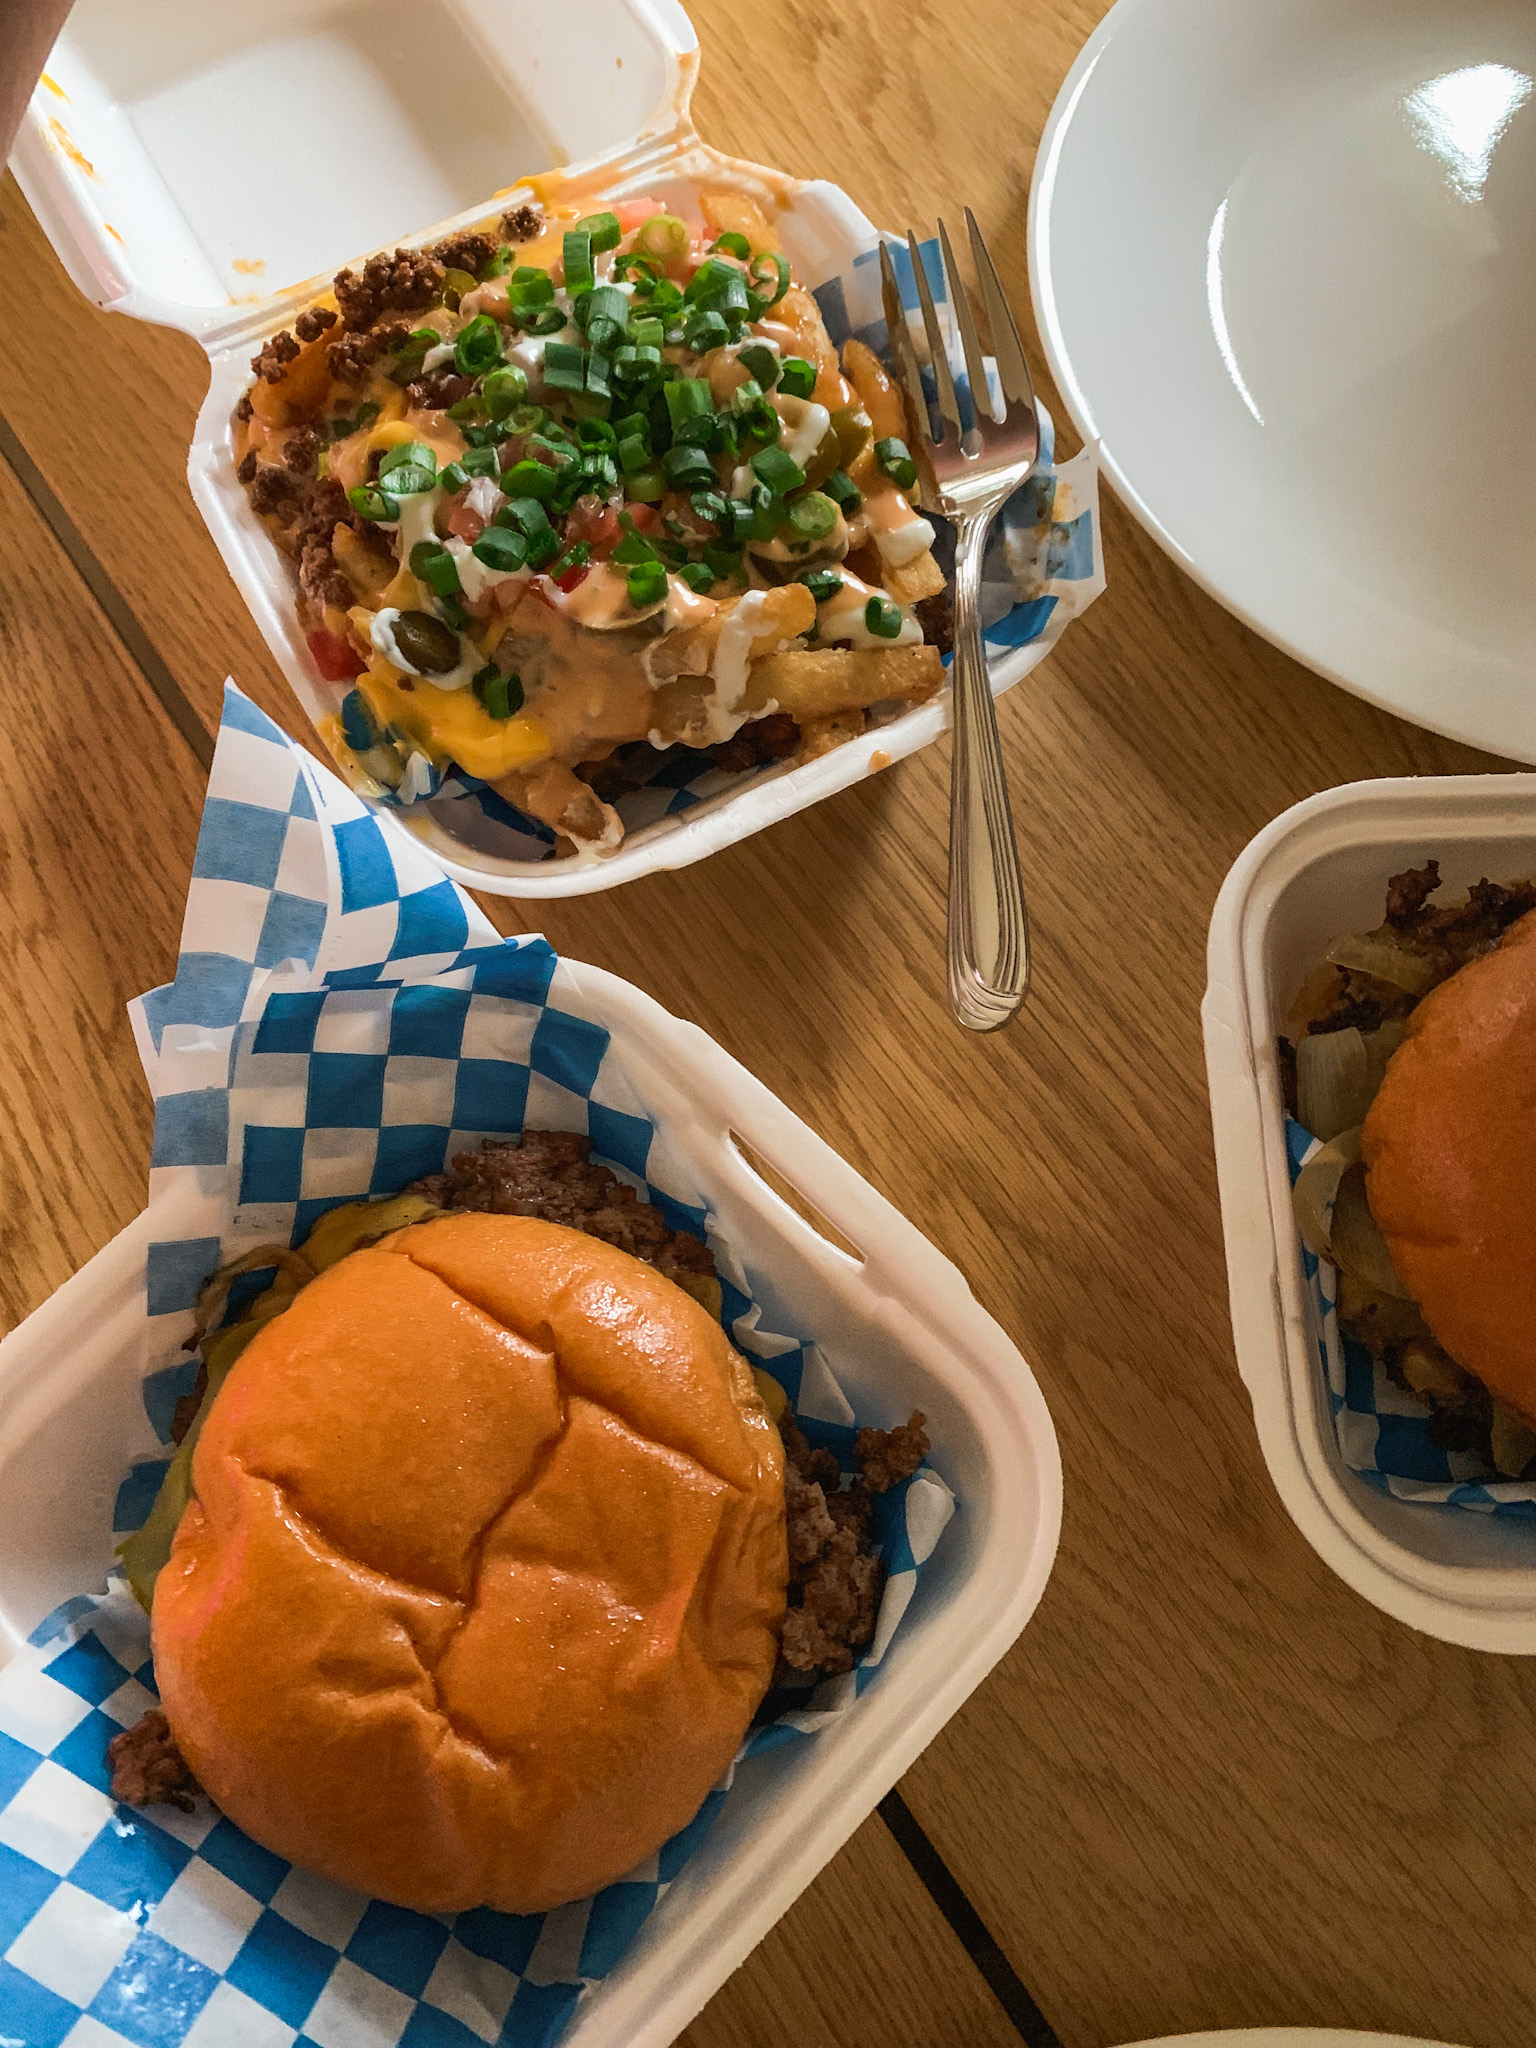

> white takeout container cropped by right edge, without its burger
[1202,774,1536,1655]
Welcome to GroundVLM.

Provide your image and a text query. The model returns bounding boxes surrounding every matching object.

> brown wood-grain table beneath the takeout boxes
[0,0,1536,2048]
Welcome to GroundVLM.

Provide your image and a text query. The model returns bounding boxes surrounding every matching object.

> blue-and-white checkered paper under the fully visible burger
[0,686,954,2048]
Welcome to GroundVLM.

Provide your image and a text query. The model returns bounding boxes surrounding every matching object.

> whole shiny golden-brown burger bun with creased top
[154,1214,786,1913]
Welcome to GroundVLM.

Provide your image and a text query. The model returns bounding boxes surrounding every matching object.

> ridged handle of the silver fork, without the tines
[948,512,1030,1032]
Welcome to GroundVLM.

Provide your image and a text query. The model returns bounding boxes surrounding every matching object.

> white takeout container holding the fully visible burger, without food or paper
[0,965,1061,2048]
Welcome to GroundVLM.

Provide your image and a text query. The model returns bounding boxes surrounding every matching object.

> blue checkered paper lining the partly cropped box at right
[1286,1116,1536,1522]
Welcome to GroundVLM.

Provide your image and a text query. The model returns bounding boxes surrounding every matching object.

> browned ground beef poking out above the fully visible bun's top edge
[406,1130,715,1280]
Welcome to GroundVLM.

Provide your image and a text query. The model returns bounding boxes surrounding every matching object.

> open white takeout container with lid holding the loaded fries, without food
[12,0,1044,897]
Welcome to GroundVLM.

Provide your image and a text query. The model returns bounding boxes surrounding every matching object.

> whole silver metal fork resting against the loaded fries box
[881,220,1040,1030]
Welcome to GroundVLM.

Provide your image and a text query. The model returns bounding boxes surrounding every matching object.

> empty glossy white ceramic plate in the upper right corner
[1030,0,1536,760]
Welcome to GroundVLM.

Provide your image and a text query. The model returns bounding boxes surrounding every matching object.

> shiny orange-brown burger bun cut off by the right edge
[1360,913,1536,1427]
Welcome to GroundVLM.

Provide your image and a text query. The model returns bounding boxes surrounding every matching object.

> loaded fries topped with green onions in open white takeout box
[16,0,1102,895]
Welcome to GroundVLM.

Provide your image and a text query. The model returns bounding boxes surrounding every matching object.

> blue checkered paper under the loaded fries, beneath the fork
[366,240,1104,860]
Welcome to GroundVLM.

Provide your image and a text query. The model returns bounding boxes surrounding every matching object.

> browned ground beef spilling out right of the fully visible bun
[778,1413,928,1686]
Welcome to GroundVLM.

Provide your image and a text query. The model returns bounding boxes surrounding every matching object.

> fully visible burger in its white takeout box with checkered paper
[0,688,1061,2048]
